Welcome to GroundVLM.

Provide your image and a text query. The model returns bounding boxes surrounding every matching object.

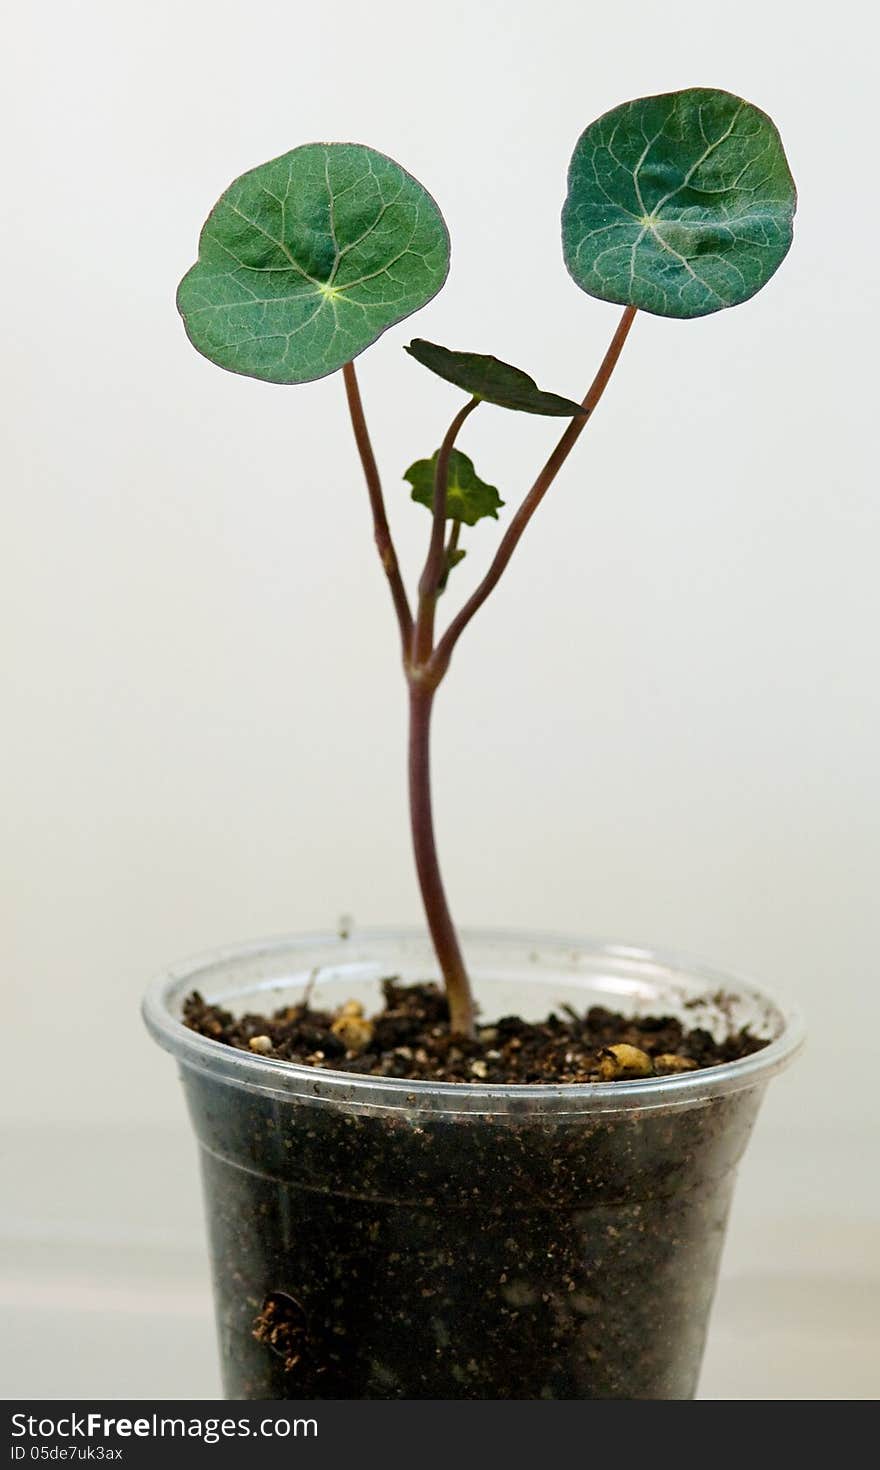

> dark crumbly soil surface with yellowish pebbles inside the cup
[184,980,767,1083]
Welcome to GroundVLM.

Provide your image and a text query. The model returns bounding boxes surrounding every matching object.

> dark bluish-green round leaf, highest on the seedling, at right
[563,87,796,316]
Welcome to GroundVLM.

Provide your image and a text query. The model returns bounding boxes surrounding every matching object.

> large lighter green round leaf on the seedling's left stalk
[178,143,450,382]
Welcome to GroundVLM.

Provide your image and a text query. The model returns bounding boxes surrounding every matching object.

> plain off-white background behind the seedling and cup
[0,0,880,1398]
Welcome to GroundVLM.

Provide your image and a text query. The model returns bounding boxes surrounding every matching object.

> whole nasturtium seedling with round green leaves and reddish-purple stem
[178,87,796,1035]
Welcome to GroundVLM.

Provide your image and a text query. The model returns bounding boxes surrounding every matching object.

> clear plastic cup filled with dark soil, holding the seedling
[144,931,802,1399]
